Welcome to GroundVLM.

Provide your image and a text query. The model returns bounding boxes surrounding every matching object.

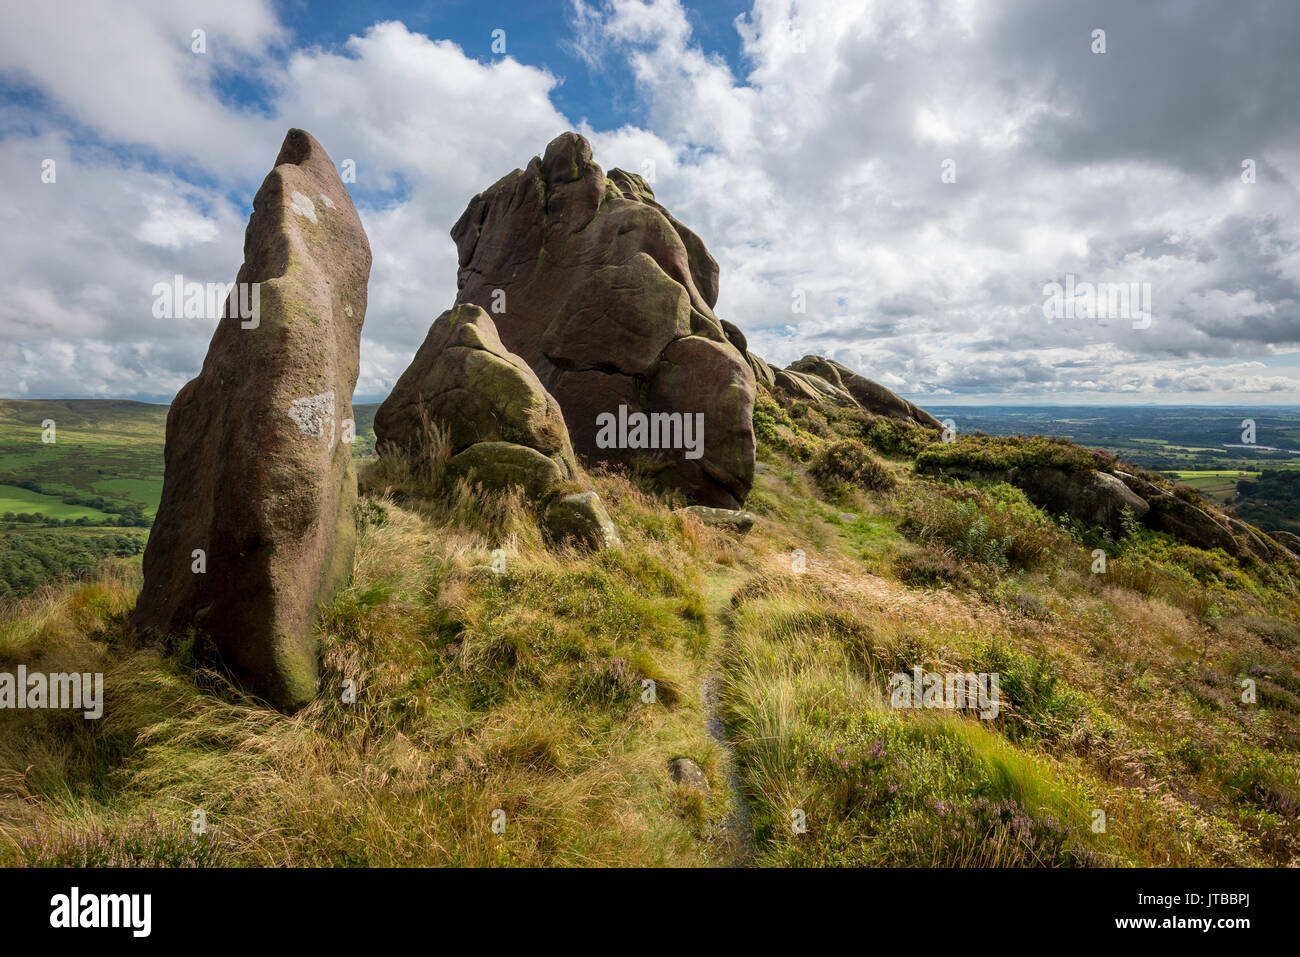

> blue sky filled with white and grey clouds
[0,0,1300,406]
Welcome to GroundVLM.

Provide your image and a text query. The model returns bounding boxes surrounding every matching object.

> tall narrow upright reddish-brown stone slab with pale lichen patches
[131,130,371,711]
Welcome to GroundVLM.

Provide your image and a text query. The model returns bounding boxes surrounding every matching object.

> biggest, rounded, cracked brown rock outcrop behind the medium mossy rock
[451,133,755,507]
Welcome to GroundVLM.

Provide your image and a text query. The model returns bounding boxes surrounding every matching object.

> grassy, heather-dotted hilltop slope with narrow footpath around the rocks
[0,395,1300,865]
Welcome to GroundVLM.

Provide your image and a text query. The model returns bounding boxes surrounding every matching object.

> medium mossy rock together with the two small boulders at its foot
[374,304,619,547]
